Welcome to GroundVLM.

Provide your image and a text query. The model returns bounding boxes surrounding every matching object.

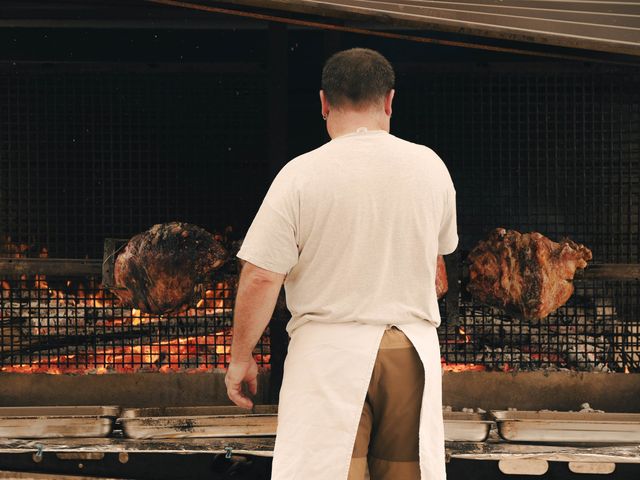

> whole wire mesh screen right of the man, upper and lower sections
[394,65,640,371]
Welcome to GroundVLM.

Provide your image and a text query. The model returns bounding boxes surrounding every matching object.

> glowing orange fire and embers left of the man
[0,262,270,375]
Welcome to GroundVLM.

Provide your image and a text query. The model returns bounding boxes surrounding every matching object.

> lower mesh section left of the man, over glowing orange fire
[0,275,270,373]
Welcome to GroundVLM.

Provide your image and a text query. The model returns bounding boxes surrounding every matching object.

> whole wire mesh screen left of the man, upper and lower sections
[0,64,270,373]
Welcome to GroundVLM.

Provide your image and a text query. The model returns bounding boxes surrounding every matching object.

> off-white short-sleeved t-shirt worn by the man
[238,129,458,333]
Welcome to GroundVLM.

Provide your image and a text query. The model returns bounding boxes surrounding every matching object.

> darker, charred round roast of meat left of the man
[114,222,227,314]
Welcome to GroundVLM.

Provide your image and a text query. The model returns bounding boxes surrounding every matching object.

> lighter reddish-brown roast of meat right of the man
[467,228,592,320]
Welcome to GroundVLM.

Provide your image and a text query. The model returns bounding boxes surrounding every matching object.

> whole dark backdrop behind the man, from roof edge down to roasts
[0,24,640,263]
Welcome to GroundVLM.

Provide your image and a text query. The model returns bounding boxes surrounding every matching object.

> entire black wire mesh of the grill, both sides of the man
[0,60,640,372]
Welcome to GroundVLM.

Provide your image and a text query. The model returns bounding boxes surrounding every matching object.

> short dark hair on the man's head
[321,48,396,107]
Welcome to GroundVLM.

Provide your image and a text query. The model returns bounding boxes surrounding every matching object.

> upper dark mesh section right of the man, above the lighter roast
[394,64,640,263]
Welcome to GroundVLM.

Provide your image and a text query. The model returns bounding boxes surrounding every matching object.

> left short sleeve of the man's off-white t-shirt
[238,167,299,275]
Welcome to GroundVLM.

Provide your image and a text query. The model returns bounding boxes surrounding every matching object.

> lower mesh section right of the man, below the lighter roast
[439,281,640,372]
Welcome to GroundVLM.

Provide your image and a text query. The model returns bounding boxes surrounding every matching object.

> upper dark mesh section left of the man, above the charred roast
[0,65,268,258]
